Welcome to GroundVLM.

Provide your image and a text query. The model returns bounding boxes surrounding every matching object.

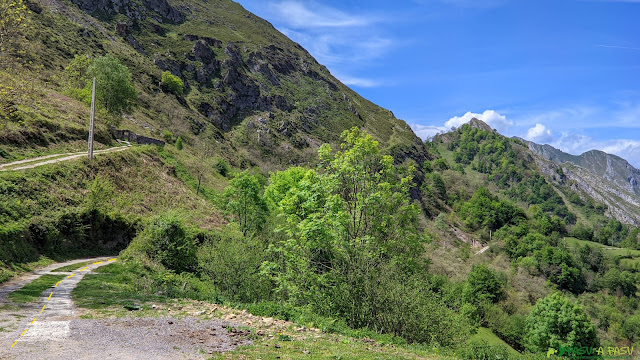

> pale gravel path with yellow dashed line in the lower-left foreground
[0,258,250,360]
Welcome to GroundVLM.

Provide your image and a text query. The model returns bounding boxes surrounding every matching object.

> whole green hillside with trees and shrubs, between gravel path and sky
[0,0,640,359]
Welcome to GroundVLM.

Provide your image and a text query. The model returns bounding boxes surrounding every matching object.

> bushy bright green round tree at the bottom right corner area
[525,293,599,352]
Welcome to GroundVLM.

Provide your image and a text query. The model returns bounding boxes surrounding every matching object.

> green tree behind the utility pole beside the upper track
[86,54,138,115]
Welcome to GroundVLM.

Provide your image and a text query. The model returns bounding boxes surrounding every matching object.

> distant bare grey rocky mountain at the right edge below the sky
[525,141,640,226]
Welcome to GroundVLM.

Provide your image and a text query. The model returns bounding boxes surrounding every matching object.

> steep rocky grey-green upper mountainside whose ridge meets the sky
[58,0,429,167]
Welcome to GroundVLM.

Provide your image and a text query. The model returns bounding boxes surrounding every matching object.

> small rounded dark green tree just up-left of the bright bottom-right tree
[462,264,504,304]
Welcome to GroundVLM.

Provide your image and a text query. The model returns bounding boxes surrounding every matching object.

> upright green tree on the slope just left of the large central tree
[224,170,267,236]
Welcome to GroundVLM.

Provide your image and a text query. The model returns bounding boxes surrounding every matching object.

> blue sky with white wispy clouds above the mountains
[239,0,640,168]
